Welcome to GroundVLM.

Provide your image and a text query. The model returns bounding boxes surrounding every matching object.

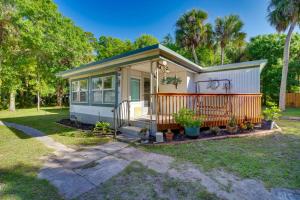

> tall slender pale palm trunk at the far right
[279,22,296,111]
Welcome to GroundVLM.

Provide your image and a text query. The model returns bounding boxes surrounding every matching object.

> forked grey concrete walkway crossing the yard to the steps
[0,122,300,200]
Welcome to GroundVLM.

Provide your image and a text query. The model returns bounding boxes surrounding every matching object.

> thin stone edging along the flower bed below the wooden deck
[144,127,282,146]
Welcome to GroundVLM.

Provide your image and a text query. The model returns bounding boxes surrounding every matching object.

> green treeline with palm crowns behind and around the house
[0,0,300,110]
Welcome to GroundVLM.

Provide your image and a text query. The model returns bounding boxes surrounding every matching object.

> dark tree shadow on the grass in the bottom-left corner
[0,164,62,200]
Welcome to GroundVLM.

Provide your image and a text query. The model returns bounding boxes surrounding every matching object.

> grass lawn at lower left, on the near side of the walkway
[0,126,61,200]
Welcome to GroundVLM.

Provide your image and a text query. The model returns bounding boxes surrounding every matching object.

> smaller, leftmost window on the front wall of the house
[72,79,88,103]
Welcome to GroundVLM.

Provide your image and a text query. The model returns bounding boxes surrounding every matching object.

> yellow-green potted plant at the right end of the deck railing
[262,102,281,130]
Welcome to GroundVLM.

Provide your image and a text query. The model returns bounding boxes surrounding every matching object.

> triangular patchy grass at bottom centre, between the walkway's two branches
[78,162,218,200]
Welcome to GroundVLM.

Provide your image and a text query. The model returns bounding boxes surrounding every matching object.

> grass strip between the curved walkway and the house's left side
[0,107,109,147]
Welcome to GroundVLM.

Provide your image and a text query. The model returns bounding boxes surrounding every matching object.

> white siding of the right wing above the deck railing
[195,67,260,93]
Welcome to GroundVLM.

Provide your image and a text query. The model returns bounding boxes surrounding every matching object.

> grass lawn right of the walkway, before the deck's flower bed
[146,120,300,189]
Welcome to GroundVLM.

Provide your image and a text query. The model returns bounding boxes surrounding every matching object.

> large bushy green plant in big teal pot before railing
[173,108,203,138]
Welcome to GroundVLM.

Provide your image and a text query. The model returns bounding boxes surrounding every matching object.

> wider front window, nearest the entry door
[91,76,115,104]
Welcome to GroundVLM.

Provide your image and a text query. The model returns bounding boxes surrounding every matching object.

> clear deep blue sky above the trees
[54,0,286,40]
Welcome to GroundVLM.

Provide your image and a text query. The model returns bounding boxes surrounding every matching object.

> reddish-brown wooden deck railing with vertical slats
[155,93,261,130]
